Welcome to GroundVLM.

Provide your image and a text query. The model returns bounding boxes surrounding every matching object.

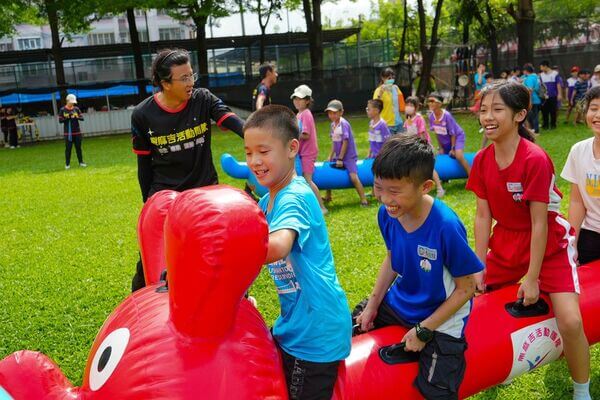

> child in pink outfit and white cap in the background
[290,85,327,214]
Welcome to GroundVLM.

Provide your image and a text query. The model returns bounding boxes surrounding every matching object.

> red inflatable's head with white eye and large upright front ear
[0,186,287,400]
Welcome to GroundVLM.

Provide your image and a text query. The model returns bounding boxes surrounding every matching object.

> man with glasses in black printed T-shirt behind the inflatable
[131,49,243,291]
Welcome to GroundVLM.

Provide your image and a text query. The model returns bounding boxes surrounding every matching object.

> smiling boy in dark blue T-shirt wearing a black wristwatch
[353,135,483,399]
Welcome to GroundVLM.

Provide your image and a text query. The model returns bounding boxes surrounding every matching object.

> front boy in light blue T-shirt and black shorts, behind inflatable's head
[244,105,352,399]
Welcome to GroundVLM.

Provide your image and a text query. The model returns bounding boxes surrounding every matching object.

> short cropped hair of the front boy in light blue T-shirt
[244,104,300,144]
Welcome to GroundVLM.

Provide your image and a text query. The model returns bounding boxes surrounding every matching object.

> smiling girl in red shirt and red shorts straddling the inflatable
[467,82,591,400]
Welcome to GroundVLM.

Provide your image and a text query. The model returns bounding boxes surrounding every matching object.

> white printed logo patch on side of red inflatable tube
[504,318,563,383]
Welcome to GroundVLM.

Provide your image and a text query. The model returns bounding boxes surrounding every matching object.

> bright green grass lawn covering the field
[0,111,600,399]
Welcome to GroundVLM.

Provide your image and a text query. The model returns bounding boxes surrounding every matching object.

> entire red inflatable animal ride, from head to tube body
[0,186,600,400]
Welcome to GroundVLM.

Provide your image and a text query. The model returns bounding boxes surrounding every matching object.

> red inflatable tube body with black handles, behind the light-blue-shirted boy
[335,262,600,400]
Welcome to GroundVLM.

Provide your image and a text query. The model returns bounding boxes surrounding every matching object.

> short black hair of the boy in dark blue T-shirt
[372,135,435,185]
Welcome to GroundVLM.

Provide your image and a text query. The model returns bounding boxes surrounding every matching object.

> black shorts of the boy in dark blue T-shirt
[352,299,467,400]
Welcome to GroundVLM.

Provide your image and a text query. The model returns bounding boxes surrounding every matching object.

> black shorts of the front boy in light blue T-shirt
[277,345,340,400]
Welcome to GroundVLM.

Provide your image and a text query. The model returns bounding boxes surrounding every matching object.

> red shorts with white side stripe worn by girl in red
[485,212,579,293]
